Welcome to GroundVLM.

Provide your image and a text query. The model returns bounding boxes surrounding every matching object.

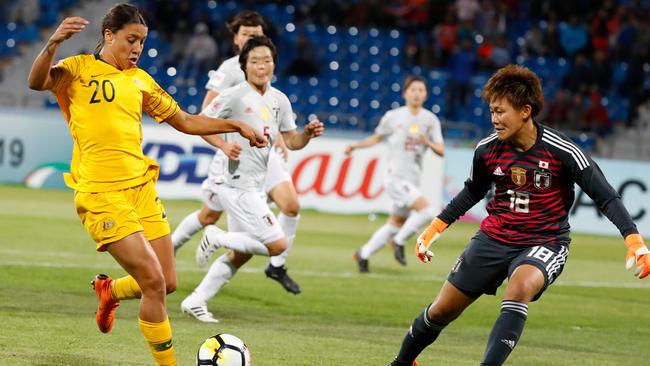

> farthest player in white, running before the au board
[345,76,445,273]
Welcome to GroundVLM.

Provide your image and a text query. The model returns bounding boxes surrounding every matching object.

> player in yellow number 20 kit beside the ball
[28,4,267,365]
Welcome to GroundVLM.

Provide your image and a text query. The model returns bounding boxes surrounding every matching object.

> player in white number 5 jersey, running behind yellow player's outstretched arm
[181,36,324,322]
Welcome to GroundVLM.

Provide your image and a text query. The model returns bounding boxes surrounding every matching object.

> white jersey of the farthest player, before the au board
[375,106,443,186]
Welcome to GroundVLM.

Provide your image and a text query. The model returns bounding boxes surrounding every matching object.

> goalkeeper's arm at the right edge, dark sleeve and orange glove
[569,150,650,278]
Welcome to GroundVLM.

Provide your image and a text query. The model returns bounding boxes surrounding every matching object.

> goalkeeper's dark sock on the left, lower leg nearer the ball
[397,305,447,365]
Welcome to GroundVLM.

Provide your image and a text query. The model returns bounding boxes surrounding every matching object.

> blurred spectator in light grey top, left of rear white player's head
[181,23,218,84]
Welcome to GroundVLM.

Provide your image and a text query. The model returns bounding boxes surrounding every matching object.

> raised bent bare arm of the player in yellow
[27,17,88,90]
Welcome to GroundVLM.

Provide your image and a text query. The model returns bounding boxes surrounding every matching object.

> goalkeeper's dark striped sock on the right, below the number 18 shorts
[481,300,528,366]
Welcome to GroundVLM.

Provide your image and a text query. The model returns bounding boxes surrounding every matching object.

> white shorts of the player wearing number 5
[204,184,284,244]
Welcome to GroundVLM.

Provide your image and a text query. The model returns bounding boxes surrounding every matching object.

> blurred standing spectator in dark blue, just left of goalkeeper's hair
[446,39,476,119]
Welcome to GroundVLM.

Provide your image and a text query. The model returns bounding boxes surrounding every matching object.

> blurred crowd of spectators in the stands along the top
[0,0,650,147]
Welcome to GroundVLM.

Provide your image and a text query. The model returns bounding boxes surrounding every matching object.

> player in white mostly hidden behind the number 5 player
[172,10,301,294]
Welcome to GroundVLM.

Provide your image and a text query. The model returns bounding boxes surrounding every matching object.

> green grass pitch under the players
[0,186,650,366]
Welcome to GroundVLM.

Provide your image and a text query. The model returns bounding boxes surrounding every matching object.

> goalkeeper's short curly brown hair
[483,65,544,117]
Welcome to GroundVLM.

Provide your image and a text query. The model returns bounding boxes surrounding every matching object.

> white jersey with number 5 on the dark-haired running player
[201,82,296,191]
